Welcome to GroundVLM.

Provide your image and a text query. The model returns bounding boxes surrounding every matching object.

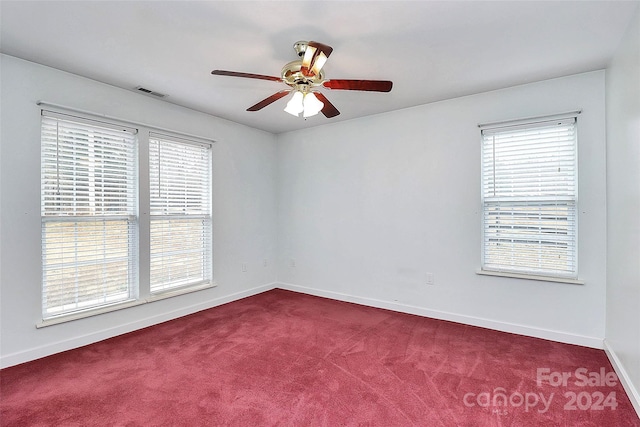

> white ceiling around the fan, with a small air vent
[0,1,639,133]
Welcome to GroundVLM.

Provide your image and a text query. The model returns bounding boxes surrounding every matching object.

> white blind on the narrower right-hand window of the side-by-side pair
[149,133,212,293]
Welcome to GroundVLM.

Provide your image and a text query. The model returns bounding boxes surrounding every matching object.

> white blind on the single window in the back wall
[482,117,577,278]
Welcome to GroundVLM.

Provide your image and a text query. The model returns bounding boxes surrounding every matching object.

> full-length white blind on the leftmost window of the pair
[41,110,137,319]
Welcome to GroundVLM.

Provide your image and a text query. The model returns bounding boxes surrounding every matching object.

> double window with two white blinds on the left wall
[36,104,215,327]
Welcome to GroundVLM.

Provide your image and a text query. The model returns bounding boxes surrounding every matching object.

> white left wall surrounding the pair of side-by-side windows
[0,55,277,366]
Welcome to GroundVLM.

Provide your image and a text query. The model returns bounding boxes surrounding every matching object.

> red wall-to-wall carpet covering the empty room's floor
[0,290,640,427]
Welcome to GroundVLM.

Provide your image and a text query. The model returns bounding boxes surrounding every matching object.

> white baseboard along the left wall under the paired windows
[0,283,277,368]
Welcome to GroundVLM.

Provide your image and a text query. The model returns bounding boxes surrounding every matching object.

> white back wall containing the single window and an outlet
[278,71,606,348]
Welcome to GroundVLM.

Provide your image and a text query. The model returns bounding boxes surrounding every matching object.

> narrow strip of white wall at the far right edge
[606,8,640,414]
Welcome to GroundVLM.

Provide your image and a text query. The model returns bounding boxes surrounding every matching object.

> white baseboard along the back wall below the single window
[276,283,603,350]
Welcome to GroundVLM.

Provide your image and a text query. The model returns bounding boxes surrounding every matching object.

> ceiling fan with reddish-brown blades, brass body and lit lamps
[211,41,393,118]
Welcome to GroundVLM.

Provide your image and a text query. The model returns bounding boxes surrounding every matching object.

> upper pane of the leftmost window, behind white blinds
[42,117,135,216]
